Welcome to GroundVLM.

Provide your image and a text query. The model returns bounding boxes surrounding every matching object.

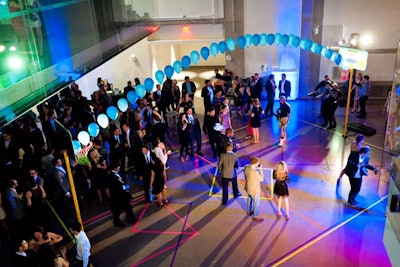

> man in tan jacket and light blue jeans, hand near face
[244,157,264,222]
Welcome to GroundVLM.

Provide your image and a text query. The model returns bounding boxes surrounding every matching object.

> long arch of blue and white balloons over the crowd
[72,33,342,150]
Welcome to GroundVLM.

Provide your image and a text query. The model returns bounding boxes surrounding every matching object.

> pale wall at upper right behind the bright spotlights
[320,0,400,81]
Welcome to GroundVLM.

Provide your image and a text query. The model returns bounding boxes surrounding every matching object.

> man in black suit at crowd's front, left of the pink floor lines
[109,163,138,227]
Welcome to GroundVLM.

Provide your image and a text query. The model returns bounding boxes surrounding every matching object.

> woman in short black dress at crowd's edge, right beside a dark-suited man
[151,157,168,207]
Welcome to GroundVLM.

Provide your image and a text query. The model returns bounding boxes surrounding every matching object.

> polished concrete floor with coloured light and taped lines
[82,97,392,267]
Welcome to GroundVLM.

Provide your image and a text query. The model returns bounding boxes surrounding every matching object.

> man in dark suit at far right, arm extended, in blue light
[345,147,378,206]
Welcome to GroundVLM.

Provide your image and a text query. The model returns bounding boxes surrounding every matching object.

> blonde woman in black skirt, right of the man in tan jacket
[272,161,290,220]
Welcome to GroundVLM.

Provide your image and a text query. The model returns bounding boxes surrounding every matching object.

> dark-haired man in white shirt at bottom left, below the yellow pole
[70,222,91,267]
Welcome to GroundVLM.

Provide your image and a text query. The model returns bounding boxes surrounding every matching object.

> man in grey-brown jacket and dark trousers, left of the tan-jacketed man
[218,145,241,205]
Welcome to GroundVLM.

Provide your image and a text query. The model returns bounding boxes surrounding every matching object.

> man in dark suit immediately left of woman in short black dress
[138,145,156,202]
